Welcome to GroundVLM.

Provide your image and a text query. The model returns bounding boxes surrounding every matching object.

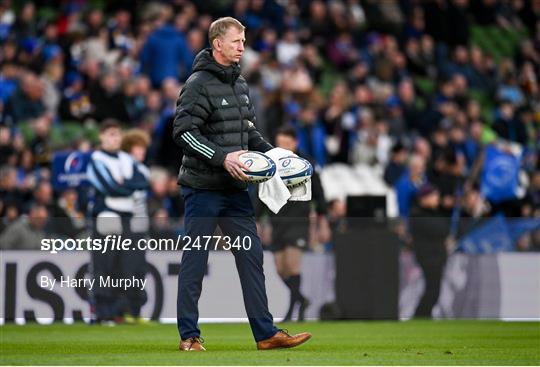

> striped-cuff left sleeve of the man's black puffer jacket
[173,79,226,167]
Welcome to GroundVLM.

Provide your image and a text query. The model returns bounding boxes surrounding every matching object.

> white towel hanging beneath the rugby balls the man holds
[259,148,311,214]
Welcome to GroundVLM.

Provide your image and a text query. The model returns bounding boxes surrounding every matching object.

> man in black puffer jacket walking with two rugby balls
[173,17,311,350]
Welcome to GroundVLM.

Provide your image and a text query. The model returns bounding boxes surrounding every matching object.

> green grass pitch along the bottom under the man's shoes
[0,320,540,365]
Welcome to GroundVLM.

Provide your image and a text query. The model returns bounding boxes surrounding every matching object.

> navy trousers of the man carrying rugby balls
[177,186,278,341]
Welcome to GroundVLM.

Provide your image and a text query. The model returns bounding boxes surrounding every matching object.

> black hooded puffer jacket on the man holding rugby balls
[173,49,272,190]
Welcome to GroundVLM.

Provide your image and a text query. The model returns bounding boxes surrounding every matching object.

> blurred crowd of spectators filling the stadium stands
[0,0,540,250]
